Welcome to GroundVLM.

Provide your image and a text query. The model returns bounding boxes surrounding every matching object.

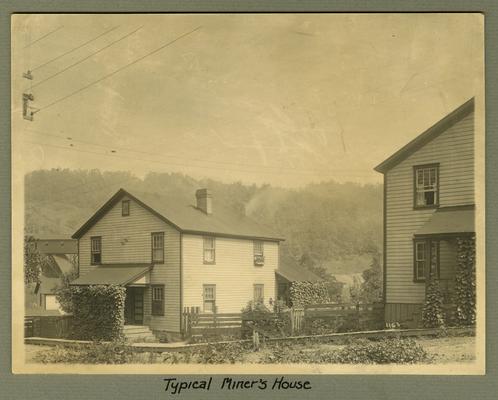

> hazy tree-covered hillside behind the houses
[25,169,382,274]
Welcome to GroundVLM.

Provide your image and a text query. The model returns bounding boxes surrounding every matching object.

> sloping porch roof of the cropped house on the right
[415,205,475,236]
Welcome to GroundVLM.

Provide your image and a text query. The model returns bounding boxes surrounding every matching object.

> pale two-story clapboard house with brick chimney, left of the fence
[72,189,283,337]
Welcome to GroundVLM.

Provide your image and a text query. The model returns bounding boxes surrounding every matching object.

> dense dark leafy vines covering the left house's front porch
[57,285,126,341]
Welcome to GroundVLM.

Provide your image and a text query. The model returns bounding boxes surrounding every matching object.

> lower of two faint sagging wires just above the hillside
[25,140,370,176]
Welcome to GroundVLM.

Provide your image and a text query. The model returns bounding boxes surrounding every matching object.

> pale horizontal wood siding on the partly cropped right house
[384,113,474,304]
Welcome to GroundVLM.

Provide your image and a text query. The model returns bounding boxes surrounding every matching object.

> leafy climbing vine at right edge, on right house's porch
[454,237,476,325]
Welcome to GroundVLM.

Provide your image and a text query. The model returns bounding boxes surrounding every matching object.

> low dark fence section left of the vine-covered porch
[24,315,73,339]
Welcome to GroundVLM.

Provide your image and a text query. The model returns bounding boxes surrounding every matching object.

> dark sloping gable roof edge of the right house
[374,97,474,173]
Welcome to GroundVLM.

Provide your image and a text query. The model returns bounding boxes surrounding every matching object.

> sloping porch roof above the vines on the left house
[71,264,152,285]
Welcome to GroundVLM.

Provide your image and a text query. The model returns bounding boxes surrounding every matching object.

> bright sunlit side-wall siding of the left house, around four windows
[183,234,279,313]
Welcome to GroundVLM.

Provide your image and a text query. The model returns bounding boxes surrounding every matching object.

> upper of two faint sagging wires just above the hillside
[25,129,368,173]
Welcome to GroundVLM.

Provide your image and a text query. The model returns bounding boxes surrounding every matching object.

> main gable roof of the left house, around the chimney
[72,189,284,241]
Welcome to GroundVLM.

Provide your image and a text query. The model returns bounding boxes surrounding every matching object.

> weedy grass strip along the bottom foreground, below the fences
[26,336,475,364]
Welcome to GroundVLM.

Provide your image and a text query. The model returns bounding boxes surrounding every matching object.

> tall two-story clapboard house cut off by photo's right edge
[375,98,475,325]
